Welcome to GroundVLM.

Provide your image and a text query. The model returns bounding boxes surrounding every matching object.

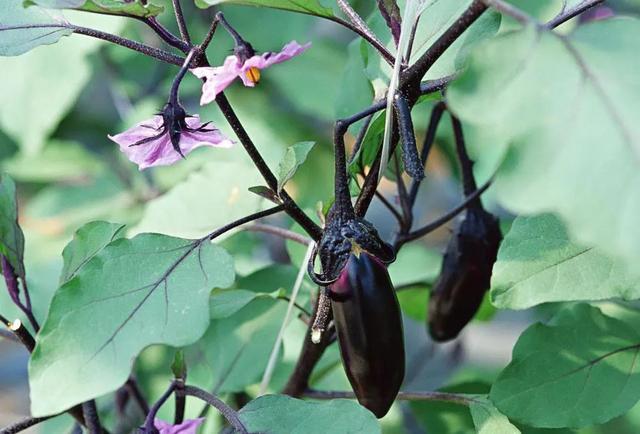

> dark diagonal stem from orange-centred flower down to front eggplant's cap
[216,92,322,241]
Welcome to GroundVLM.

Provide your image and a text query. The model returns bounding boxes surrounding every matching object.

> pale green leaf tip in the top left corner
[0,0,72,56]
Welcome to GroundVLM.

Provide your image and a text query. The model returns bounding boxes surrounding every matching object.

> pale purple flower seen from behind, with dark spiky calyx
[109,102,233,170]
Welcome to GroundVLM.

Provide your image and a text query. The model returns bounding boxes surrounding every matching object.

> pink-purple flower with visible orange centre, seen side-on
[191,41,311,105]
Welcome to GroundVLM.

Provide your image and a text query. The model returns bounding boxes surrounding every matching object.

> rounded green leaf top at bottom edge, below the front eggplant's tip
[239,395,381,434]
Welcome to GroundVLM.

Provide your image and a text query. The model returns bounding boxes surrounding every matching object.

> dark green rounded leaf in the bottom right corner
[490,304,640,428]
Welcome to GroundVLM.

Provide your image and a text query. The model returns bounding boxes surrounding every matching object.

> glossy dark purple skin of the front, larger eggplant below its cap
[329,252,405,418]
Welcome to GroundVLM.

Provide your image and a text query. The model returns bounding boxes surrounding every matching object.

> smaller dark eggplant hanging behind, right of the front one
[427,207,502,342]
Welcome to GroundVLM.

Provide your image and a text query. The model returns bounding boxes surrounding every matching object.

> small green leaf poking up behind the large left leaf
[60,221,124,285]
